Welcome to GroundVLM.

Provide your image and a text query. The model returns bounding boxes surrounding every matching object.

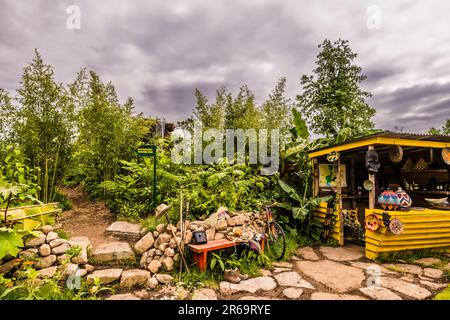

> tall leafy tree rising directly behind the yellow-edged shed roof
[297,39,375,137]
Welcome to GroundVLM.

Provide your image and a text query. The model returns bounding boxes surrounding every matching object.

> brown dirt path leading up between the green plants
[60,187,115,247]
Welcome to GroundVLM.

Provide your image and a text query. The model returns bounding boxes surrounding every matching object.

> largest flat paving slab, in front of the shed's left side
[295,260,365,293]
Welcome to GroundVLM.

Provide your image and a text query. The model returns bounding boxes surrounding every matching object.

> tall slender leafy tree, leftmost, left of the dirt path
[13,50,74,202]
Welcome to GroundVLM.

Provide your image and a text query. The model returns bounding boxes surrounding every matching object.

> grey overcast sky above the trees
[0,0,450,132]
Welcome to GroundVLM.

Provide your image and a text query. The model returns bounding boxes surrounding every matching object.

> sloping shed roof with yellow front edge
[309,130,450,158]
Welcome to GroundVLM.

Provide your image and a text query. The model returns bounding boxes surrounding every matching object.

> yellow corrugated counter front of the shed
[365,209,450,259]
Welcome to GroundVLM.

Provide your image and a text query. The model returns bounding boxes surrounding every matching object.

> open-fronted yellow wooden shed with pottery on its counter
[309,131,450,259]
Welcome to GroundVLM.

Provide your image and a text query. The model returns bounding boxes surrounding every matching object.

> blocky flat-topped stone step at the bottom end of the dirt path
[92,242,136,263]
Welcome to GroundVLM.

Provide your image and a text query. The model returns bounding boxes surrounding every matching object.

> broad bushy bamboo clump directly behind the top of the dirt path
[69,70,144,195]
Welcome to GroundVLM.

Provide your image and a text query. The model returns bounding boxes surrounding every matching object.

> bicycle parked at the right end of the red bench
[263,203,286,261]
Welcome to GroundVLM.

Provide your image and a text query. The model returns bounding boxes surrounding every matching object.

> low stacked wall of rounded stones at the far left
[0,225,92,277]
